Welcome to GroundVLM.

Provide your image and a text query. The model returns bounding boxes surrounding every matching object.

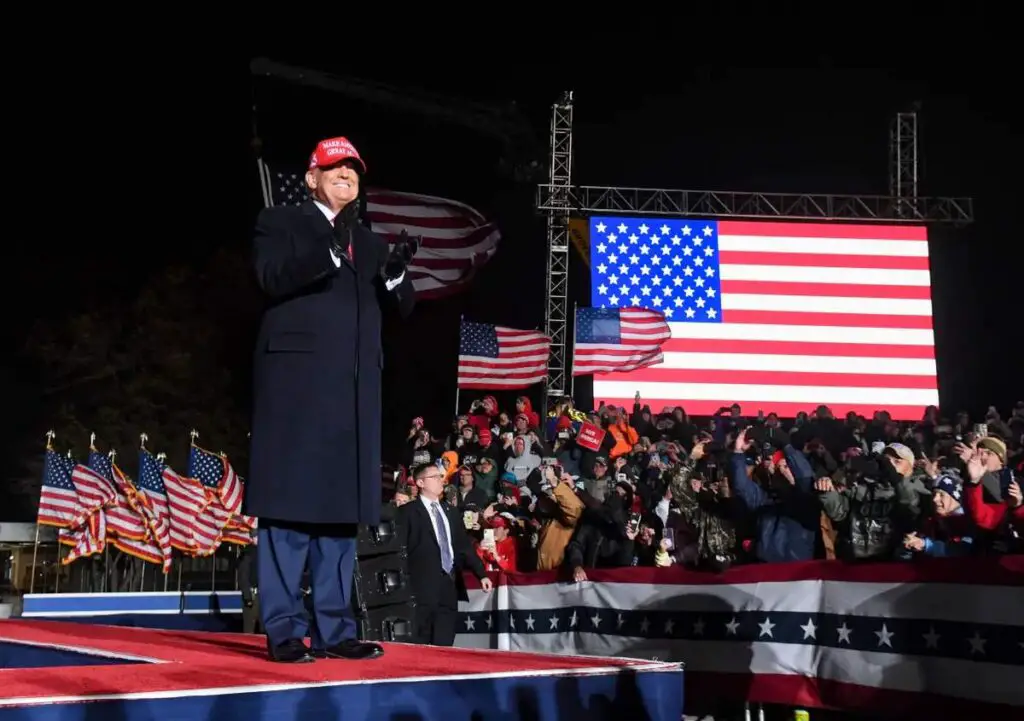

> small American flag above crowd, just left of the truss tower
[459,321,551,389]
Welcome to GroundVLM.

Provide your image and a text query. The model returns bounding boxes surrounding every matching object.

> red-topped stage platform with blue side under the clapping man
[0,620,683,721]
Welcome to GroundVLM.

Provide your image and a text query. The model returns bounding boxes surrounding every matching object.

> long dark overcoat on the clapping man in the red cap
[245,201,415,523]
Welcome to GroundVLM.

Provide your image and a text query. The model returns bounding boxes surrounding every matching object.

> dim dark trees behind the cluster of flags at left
[8,251,262,515]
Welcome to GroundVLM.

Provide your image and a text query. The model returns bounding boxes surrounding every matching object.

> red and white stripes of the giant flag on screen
[594,220,939,420]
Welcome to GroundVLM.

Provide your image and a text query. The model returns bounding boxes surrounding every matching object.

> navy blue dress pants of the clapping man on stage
[256,518,357,649]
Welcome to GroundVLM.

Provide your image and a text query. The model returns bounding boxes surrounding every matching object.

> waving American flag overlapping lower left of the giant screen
[572,308,672,376]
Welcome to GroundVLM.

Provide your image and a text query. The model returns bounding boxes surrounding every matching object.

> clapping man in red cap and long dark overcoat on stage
[246,137,416,663]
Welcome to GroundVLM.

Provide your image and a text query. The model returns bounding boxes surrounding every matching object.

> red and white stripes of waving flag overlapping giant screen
[572,308,672,376]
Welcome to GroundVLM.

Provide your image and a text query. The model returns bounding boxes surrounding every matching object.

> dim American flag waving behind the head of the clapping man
[271,171,502,299]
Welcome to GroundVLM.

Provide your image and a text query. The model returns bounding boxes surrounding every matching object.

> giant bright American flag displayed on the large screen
[590,217,938,420]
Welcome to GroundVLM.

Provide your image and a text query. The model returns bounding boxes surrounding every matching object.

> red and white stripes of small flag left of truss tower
[459,326,551,389]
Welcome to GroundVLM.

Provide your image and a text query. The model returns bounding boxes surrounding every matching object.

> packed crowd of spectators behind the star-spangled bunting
[393,394,1024,581]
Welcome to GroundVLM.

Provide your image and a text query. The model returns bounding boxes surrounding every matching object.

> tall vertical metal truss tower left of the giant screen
[544,90,572,399]
